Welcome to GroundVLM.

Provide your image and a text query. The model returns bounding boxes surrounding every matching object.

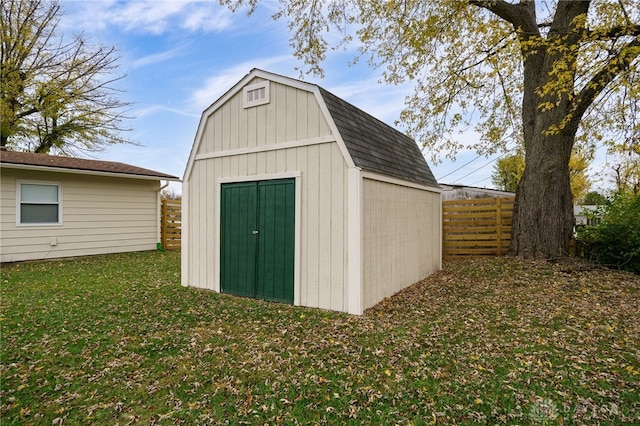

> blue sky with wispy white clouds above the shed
[60,0,608,192]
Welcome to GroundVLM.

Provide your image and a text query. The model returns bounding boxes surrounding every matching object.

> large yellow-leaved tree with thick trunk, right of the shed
[219,0,640,258]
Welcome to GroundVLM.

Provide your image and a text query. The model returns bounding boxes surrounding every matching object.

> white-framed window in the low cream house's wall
[18,182,62,225]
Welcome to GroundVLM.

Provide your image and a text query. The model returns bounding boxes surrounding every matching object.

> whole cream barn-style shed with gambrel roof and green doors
[182,69,442,314]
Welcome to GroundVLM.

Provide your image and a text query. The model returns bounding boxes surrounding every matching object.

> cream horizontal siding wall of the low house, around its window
[0,168,160,262]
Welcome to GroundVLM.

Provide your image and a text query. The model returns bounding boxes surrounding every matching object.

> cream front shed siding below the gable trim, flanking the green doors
[183,142,347,311]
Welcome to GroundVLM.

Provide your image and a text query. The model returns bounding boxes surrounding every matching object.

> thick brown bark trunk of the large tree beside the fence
[498,0,590,259]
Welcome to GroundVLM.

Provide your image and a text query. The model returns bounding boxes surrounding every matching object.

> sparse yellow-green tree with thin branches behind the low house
[0,0,128,154]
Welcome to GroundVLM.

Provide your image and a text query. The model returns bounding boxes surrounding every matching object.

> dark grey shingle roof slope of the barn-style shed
[319,87,438,188]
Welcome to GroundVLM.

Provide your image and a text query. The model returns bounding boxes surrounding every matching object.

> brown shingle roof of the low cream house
[0,150,179,180]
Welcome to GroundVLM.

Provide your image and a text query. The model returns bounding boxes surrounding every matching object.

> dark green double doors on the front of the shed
[220,179,295,304]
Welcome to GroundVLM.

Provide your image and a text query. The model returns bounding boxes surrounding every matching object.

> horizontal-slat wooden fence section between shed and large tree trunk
[442,197,515,260]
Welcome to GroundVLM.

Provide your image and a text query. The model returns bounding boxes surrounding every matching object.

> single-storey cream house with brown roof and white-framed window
[0,150,179,262]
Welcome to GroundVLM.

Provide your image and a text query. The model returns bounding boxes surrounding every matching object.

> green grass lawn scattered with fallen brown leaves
[0,252,640,426]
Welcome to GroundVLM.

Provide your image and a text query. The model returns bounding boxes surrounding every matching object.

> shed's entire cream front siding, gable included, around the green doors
[182,79,347,311]
